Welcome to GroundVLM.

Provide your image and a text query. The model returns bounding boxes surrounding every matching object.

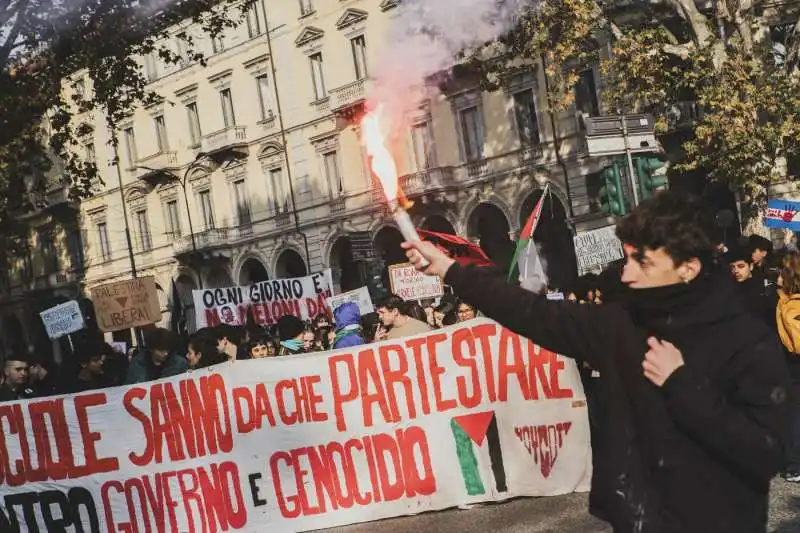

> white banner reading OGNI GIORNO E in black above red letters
[192,269,333,329]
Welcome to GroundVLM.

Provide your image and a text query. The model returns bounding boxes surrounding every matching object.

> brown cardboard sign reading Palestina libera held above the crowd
[91,276,161,332]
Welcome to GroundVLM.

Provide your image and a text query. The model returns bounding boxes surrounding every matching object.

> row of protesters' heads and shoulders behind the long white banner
[0,295,476,402]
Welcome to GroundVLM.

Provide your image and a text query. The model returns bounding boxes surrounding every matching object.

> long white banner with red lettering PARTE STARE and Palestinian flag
[0,319,591,533]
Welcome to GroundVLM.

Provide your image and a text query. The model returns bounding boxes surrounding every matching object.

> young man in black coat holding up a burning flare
[403,192,790,533]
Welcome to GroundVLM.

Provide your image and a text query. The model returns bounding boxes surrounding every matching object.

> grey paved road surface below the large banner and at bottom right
[324,481,800,533]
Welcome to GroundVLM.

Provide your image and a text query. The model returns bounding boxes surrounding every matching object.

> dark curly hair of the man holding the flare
[617,191,714,266]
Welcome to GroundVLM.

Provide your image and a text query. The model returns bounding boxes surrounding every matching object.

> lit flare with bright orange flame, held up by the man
[361,106,428,268]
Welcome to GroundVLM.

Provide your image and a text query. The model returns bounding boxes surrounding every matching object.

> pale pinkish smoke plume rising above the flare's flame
[368,0,531,130]
